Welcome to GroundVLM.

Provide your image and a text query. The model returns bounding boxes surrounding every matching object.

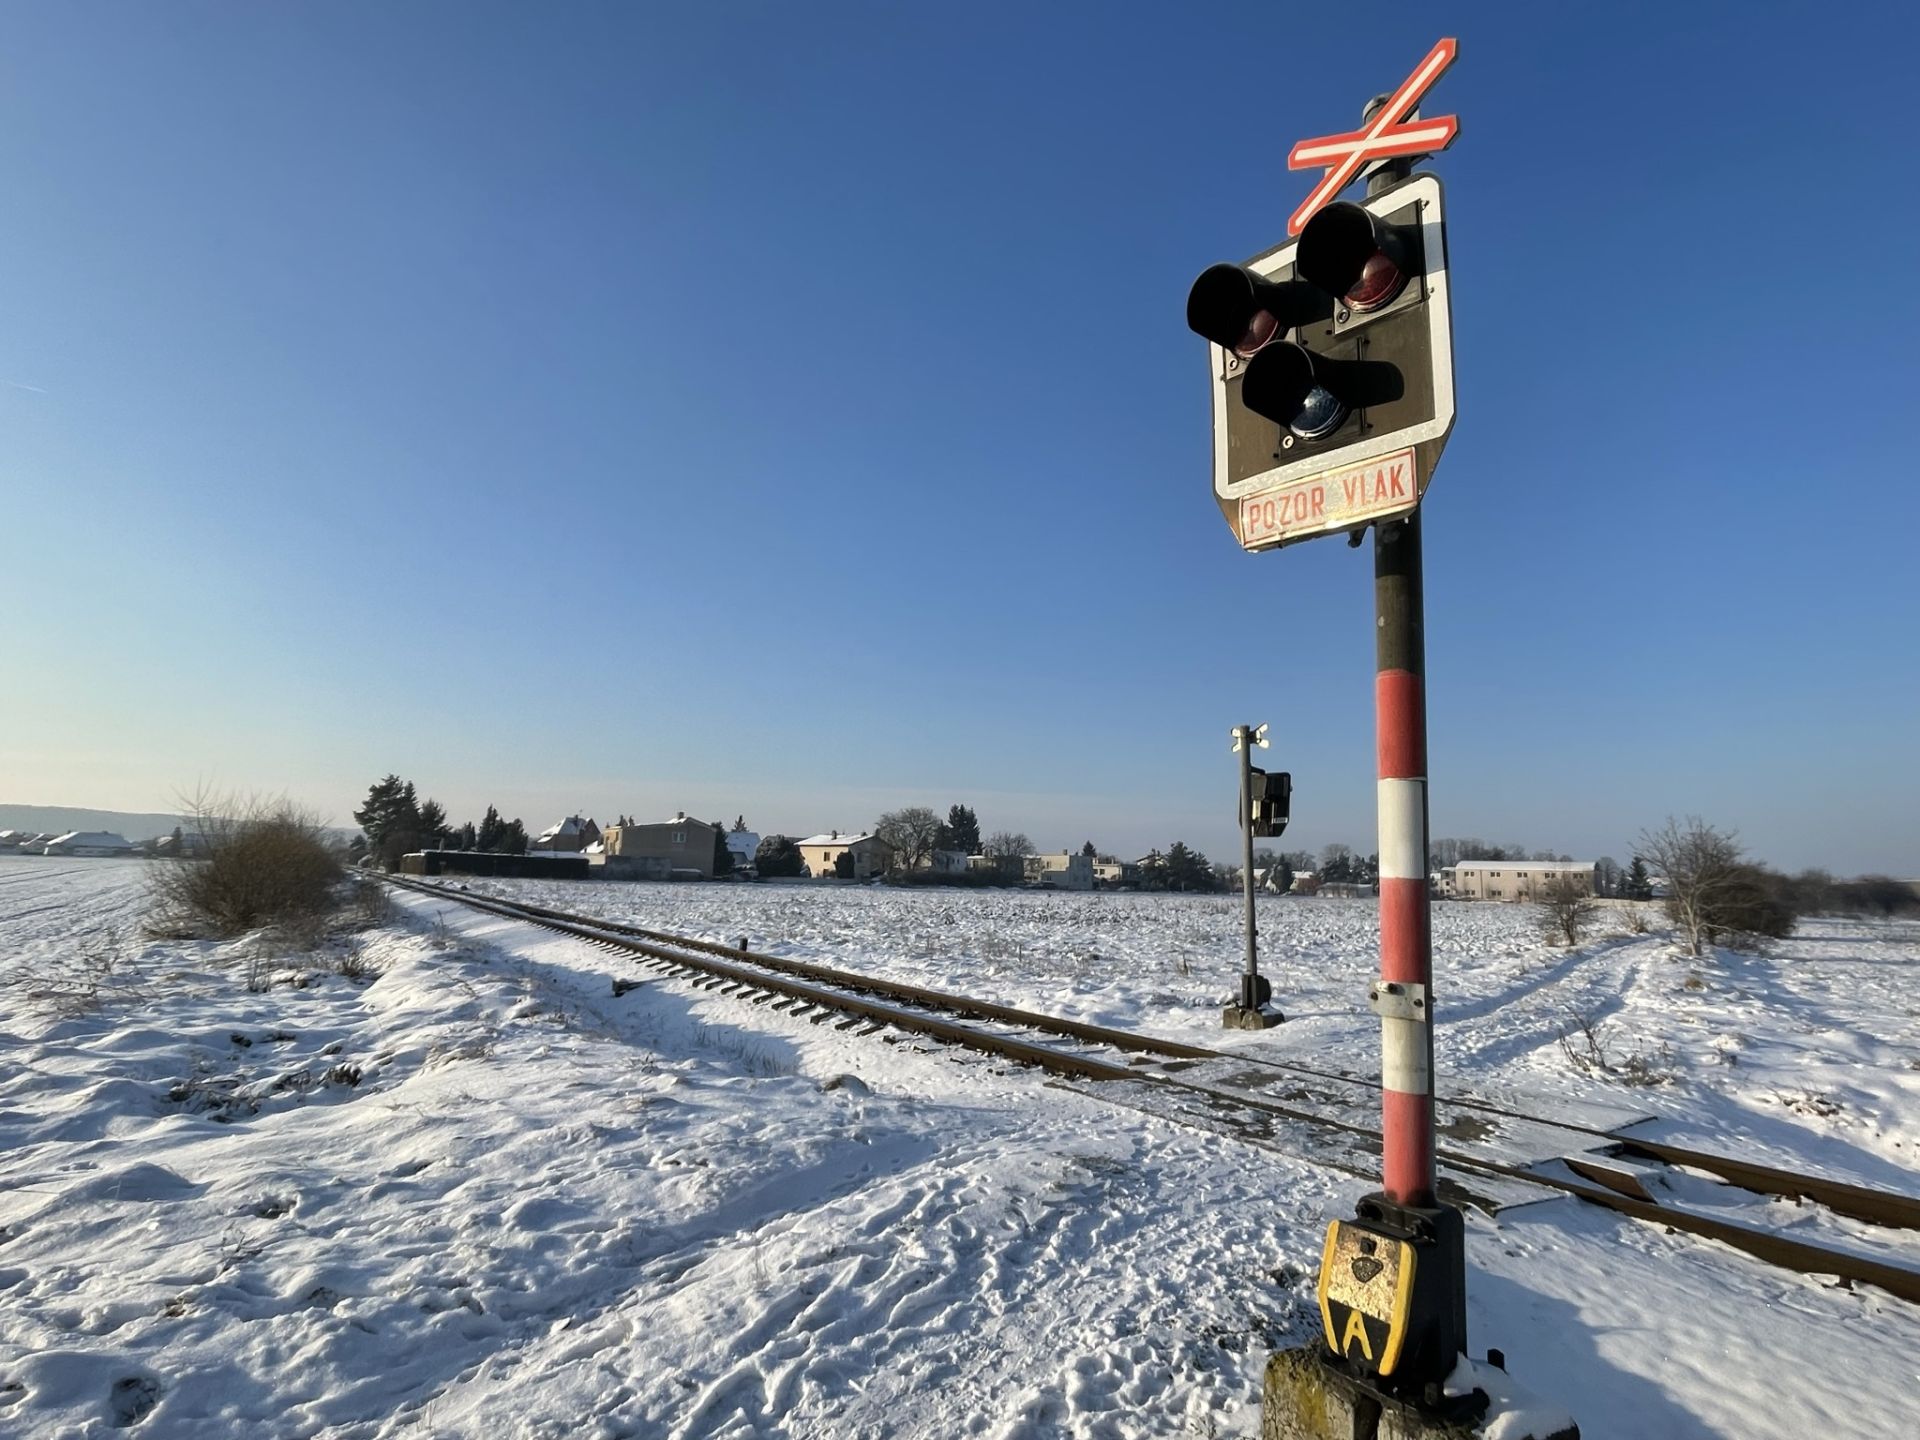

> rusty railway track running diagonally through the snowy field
[386,877,1920,1304]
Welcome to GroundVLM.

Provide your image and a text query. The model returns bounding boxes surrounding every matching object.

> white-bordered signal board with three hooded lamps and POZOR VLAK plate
[1187,175,1453,551]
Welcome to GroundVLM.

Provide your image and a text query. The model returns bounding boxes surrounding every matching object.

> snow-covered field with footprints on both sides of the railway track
[0,858,1920,1440]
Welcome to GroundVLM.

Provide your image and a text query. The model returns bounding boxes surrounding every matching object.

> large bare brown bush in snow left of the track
[150,795,342,937]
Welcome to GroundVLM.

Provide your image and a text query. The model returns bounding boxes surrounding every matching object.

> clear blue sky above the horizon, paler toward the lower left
[0,0,1920,874]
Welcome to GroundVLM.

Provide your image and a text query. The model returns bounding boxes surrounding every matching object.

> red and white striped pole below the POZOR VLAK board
[1373,511,1434,1206]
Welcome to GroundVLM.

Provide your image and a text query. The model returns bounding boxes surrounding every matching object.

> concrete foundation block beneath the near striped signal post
[1260,1344,1580,1440]
